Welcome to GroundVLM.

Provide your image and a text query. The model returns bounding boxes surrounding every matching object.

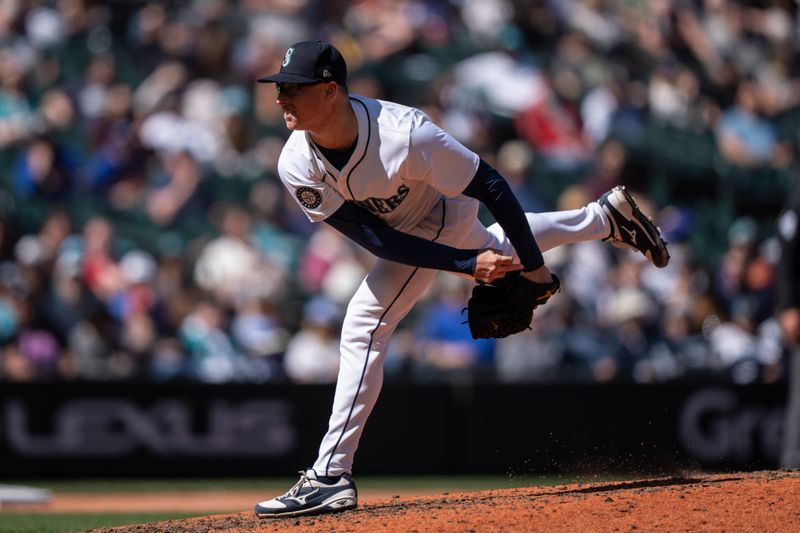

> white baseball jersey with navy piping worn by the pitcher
[278,96,479,237]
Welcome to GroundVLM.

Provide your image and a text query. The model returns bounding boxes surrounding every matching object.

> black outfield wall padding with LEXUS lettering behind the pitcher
[0,383,786,479]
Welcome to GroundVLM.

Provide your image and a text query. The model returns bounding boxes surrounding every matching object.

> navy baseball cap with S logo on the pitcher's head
[258,41,347,85]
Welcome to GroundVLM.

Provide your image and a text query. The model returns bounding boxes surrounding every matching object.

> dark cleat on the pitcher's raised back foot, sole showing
[597,186,669,268]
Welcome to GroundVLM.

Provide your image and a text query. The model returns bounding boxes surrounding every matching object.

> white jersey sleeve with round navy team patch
[278,145,344,222]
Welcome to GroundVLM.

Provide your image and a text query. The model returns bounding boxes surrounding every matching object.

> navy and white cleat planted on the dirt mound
[255,468,358,518]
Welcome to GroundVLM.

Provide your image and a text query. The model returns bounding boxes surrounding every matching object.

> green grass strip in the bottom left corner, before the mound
[0,511,199,533]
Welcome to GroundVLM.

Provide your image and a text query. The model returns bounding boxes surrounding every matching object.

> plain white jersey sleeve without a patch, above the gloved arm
[408,112,479,198]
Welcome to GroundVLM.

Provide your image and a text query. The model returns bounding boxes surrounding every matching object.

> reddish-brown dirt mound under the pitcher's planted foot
[97,472,800,533]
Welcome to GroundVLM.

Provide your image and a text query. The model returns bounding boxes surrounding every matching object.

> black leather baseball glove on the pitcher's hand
[467,272,561,339]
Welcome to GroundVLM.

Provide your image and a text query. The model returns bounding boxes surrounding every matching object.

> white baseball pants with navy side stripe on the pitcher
[314,202,611,476]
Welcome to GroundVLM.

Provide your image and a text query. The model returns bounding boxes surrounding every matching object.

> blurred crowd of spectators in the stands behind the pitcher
[0,0,800,383]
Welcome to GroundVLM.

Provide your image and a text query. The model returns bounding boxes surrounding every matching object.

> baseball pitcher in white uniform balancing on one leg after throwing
[255,41,669,517]
